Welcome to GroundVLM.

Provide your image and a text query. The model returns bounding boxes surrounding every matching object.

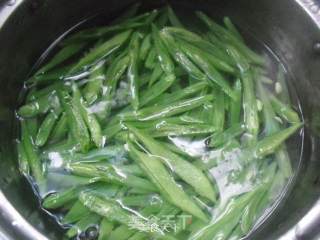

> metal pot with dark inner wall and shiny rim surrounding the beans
[0,0,320,240]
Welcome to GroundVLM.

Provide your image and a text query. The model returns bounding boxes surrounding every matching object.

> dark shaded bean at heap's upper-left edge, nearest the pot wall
[36,43,86,75]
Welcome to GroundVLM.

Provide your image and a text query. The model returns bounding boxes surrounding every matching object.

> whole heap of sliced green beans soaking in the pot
[17,5,302,240]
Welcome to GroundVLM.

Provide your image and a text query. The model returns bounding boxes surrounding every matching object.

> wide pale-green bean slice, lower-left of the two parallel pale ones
[129,143,207,221]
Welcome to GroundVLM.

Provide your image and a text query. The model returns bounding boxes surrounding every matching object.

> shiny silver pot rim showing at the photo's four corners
[0,0,320,240]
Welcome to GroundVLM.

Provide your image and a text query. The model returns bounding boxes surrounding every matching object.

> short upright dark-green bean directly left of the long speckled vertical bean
[229,79,242,126]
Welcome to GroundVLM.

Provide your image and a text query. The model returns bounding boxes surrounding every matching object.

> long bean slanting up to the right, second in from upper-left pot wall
[69,30,131,75]
